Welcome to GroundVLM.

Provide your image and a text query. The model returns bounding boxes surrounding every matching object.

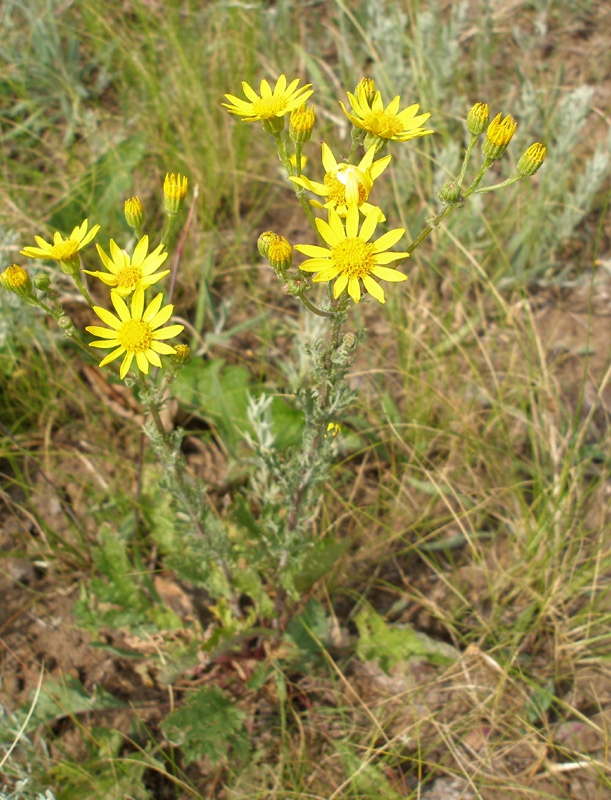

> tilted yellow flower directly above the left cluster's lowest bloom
[83,236,170,297]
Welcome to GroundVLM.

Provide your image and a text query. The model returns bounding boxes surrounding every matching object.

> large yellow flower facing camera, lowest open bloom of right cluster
[295,205,409,303]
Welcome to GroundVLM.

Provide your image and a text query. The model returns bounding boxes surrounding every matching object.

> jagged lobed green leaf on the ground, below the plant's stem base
[161,686,250,766]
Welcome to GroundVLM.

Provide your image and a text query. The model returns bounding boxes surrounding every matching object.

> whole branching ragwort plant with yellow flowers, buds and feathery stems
[0,75,546,632]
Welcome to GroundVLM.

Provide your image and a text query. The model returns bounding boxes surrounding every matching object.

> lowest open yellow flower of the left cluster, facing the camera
[86,286,184,379]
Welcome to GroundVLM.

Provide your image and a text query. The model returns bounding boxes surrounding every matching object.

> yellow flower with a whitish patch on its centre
[290,144,391,222]
